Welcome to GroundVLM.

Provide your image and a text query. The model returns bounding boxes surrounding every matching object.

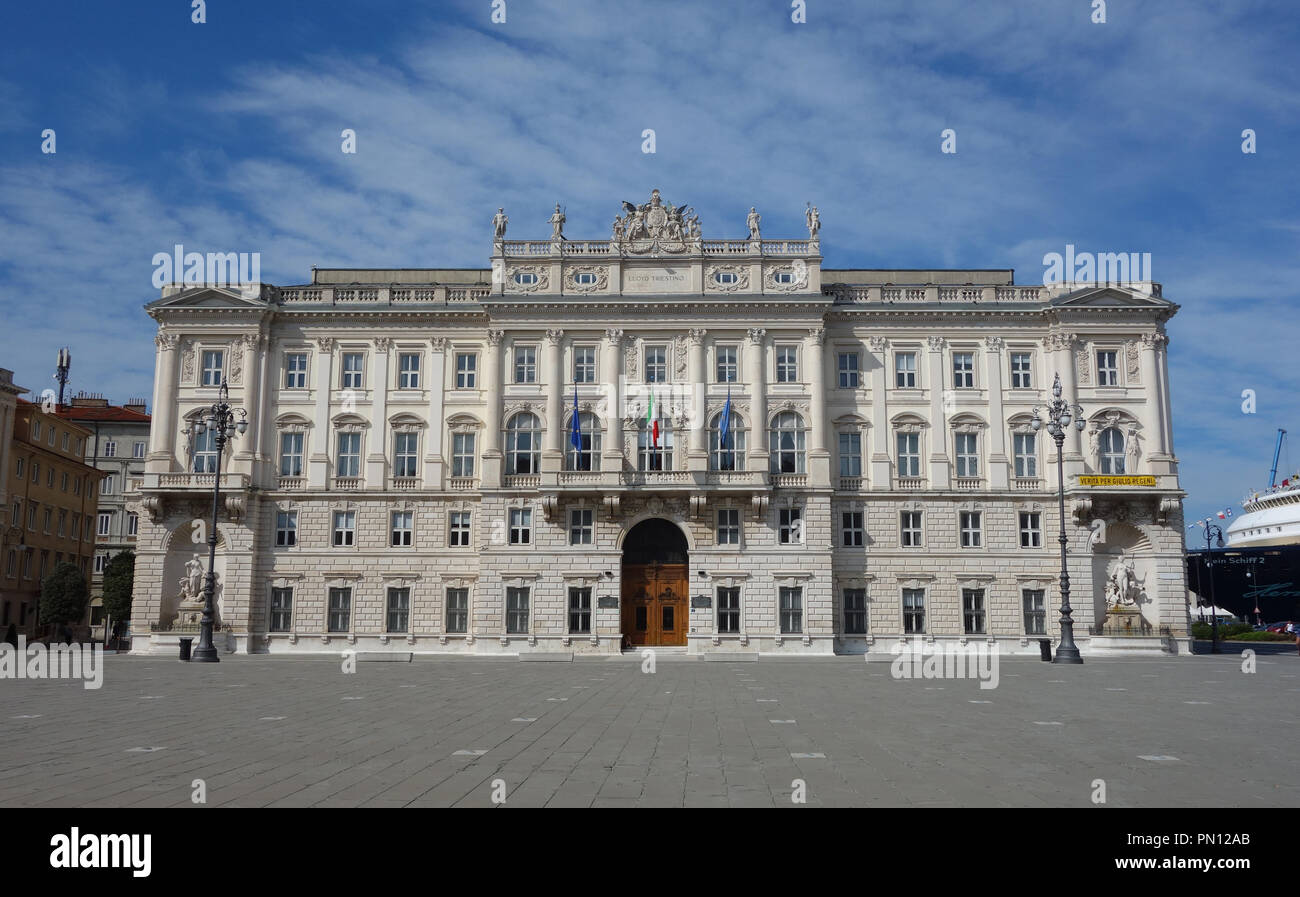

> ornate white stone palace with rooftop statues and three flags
[131,191,1187,655]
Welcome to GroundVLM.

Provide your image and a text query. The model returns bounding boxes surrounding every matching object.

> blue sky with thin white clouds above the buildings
[0,0,1300,519]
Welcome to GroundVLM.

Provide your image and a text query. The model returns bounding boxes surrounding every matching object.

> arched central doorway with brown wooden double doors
[621,517,690,646]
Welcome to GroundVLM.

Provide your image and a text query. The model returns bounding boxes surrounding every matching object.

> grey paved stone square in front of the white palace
[0,649,1300,807]
